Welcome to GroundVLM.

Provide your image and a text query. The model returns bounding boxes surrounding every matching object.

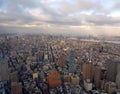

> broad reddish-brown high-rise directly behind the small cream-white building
[82,63,93,81]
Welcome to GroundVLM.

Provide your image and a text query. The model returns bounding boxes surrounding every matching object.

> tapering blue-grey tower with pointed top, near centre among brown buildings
[67,50,76,73]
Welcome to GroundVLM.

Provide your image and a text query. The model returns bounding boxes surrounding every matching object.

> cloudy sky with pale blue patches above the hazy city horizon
[0,0,120,36]
